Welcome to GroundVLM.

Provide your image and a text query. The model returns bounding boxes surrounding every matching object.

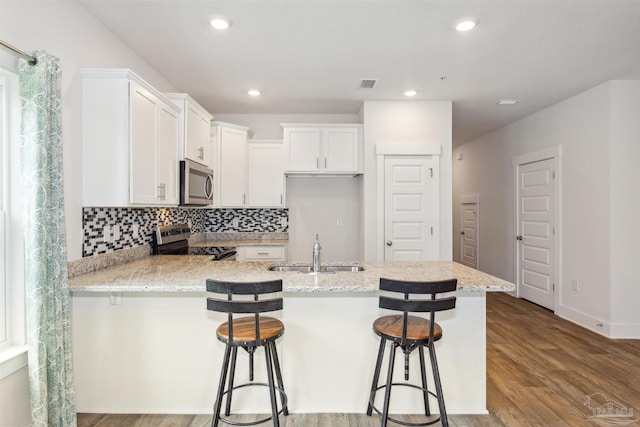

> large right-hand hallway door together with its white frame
[513,148,559,310]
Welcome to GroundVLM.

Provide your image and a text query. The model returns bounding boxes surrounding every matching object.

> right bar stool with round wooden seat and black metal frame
[367,278,458,427]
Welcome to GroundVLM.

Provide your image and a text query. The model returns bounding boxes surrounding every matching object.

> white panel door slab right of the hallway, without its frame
[516,159,555,310]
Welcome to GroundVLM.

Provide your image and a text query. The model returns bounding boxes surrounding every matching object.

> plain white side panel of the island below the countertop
[71,292,486,414]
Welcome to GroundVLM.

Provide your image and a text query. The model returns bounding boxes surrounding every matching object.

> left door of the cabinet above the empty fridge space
[284,128,321,172]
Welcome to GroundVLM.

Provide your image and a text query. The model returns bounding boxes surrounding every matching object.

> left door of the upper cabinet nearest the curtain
[129,82,160,204]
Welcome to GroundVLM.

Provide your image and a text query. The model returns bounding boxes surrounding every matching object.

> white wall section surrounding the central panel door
[362,101,452,261]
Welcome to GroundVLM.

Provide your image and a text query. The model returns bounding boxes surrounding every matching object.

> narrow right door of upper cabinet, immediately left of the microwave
[156,104,180,205]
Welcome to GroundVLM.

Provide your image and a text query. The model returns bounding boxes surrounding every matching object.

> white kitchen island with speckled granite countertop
[69,256,514,413]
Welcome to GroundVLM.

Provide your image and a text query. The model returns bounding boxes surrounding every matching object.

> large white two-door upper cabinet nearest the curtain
[80,69,180,206]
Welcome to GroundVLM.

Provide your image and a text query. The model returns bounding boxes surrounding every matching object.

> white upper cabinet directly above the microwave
[165,93,213,167]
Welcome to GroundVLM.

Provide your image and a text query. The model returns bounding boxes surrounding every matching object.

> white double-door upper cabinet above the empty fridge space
[282,123,362,175]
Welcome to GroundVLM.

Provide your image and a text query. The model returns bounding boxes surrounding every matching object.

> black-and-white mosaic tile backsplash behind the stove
[82,207,289,257]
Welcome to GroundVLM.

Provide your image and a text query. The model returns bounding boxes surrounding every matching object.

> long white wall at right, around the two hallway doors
[453,82,640,336]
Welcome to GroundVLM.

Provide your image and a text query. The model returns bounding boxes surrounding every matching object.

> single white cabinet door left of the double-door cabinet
[247,141,285,207]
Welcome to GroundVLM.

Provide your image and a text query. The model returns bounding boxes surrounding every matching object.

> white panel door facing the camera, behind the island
[384,156,439,261]
